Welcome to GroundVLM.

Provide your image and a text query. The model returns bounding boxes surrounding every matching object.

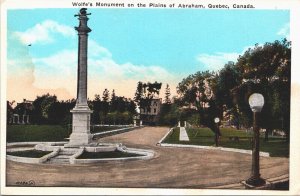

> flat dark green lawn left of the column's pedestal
[6,125,71,142]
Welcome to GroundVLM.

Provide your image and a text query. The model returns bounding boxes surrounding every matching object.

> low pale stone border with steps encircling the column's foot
[6,142,155,164]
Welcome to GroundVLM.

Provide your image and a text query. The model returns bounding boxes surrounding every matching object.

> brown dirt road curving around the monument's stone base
[6,127,289,188]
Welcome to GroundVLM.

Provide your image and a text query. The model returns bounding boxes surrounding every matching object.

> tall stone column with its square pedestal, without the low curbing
[66,8,92,146]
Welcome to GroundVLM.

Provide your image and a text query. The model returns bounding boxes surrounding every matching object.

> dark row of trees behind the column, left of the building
[8,90,135,125]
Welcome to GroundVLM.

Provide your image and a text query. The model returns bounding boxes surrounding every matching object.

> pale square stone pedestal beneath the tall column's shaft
[65,105,93,147]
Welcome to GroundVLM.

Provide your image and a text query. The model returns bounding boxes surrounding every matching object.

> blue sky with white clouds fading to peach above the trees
[7,9,290,100]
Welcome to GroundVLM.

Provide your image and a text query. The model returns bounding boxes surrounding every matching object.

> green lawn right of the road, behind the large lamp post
[164,128,289,157]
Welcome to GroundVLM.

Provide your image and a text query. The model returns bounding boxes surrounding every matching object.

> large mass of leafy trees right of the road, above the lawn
[177,39,291,142]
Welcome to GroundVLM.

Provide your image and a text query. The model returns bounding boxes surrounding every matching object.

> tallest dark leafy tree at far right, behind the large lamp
[235,39,291,140]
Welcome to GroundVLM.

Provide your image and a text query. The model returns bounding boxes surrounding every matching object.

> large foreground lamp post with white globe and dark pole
[246,93,266,186]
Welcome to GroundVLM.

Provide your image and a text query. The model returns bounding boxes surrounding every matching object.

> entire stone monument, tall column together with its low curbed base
[7,8,154,164]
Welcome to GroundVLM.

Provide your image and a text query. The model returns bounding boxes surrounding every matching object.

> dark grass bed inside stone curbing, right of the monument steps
[77,150,141,159]
